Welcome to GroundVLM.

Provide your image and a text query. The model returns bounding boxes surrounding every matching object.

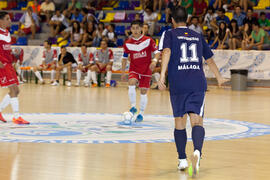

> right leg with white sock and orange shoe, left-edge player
[9,84,29,124]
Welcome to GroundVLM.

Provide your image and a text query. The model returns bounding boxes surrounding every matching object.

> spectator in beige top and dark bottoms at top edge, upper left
[40,0,55,24]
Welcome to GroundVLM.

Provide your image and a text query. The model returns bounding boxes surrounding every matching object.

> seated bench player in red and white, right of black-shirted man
[75,45,94,87]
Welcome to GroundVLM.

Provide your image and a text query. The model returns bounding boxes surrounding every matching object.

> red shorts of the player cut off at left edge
[0,64,19,87]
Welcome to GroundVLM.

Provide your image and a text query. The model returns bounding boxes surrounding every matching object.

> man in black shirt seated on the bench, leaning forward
[52,46,77,87]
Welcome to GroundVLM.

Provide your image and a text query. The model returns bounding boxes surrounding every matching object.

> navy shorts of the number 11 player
[170,92,205,117]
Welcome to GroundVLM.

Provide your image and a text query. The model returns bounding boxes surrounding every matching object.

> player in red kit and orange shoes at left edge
[0,12,29,124]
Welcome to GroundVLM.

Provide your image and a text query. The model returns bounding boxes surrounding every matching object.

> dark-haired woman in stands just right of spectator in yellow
[69,21,83,47]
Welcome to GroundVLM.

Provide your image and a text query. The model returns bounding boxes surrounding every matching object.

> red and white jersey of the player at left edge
[0,28,13,64]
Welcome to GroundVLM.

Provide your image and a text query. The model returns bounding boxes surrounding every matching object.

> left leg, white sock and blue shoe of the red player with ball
[128,73,138,114]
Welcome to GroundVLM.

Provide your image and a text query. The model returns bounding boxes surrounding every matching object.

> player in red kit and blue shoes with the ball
[121,21,160,122]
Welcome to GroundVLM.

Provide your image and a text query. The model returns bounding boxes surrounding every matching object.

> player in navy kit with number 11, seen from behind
[158,7,227,174]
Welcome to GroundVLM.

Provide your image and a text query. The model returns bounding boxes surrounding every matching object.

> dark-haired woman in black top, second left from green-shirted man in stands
[229,19,243,49]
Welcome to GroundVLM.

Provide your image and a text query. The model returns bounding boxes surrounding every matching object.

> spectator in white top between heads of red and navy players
[143,6,158,36]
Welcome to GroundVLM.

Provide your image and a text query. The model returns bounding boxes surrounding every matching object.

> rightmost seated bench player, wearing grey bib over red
[92,39,114,87]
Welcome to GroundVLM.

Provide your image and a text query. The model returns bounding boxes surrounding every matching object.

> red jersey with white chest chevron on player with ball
[123,35,159,76]
